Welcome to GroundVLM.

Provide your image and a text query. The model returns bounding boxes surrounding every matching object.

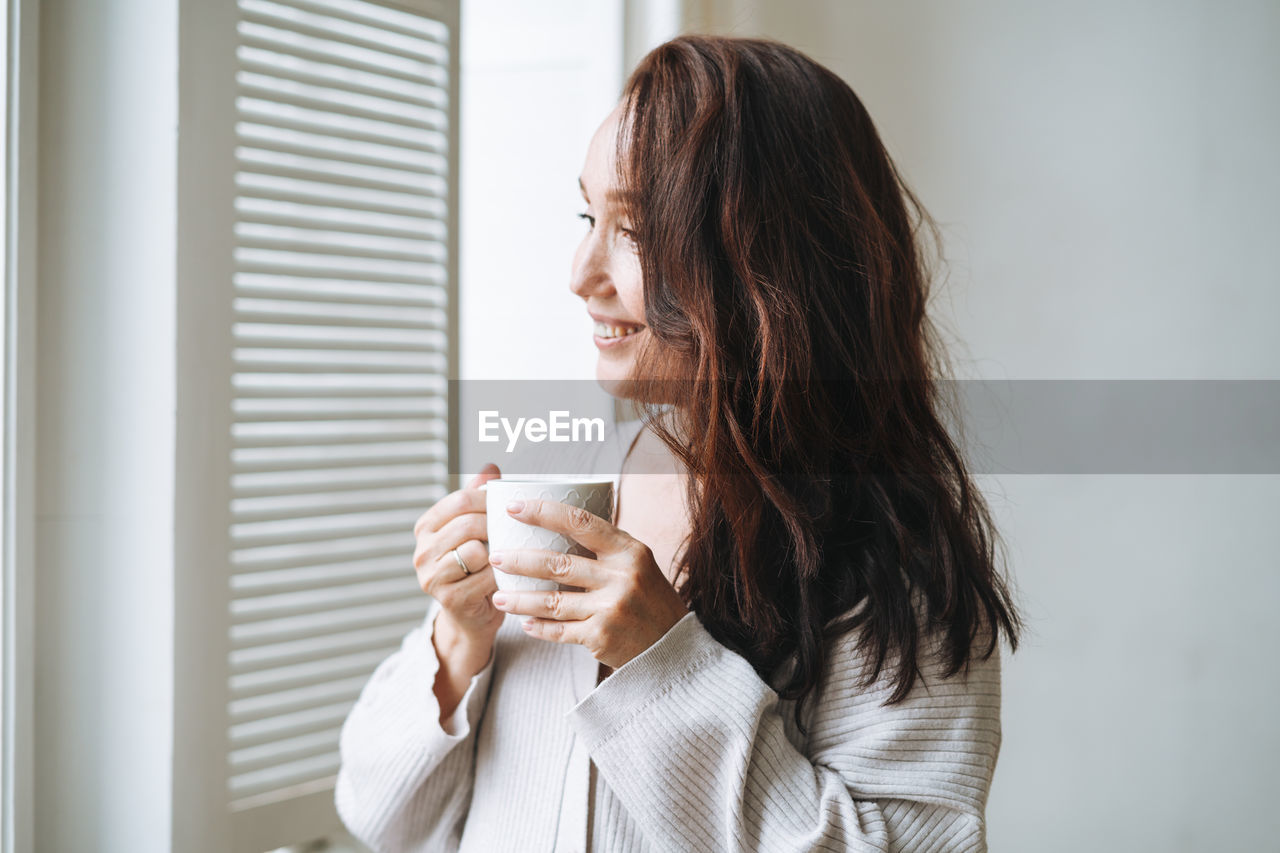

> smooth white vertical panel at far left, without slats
[34,0,178,853]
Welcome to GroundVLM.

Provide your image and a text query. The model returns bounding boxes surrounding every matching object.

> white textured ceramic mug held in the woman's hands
[480,476,614,621]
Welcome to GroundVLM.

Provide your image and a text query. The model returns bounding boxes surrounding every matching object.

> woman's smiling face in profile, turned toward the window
[570,108,649,383]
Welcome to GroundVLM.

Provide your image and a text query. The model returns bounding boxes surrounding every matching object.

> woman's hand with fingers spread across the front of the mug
[489,500,689,670]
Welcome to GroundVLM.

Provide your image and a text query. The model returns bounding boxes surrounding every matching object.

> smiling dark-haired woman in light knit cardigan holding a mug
[335,37,1019,852]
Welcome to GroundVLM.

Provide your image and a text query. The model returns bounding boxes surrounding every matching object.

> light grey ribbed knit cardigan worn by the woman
[334,421,1001,853]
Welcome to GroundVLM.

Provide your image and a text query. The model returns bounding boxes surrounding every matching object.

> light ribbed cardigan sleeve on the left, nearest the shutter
[334,599,494,853]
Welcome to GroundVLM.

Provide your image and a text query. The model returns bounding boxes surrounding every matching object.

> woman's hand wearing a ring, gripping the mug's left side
[413,462,506,644]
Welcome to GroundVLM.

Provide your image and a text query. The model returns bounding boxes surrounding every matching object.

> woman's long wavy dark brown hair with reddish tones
[617,36,1021,731]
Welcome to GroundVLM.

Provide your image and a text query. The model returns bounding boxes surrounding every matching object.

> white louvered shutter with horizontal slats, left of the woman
[186,0,458,853]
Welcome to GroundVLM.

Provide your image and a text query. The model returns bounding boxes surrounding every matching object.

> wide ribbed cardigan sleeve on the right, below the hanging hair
[567,612,1000,853]
